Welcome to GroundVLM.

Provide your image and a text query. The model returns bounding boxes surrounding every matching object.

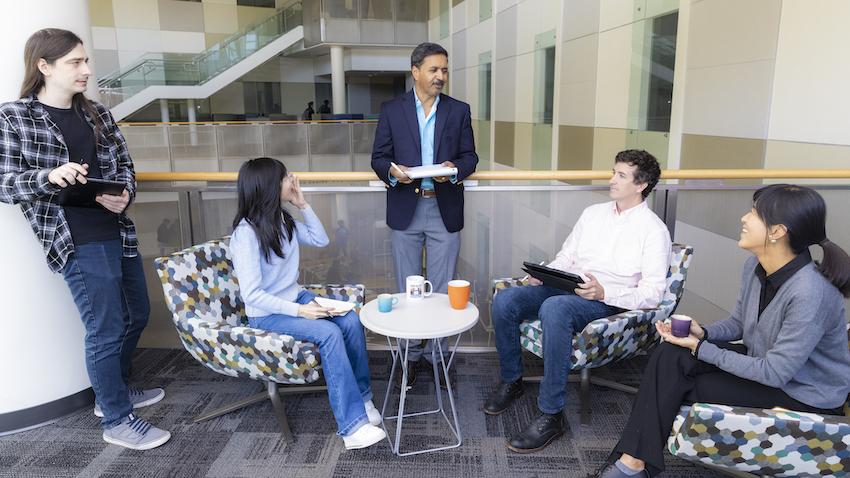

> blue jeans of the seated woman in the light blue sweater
[248,290,372,436]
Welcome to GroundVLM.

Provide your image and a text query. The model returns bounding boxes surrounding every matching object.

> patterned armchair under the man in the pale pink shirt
[493,244,694,423]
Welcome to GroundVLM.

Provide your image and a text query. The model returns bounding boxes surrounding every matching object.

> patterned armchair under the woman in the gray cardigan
[667,328,850,477]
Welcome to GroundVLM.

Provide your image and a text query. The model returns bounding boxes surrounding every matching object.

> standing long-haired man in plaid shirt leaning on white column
[0,28,171,450]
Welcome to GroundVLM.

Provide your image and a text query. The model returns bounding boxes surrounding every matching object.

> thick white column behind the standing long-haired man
[0,0,97,425]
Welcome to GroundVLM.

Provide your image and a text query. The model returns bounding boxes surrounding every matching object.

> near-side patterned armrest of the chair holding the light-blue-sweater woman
[174,318,320,384]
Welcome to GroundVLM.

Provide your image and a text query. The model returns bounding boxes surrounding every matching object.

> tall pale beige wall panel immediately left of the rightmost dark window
[596,25,633,128]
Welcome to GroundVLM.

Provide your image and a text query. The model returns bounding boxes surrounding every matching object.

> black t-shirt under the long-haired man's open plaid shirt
[42,104,121,245]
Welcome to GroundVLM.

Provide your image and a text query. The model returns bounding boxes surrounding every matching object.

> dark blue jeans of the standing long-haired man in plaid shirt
[62,239,150,428]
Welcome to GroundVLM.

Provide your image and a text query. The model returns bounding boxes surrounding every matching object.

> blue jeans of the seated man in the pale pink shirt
[486,285,623,413]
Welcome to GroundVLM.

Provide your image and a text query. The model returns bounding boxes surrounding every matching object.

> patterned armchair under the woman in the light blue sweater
[154,238,365,443]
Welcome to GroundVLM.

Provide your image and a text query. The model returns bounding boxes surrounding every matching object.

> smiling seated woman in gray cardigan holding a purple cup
[596,184,850,478]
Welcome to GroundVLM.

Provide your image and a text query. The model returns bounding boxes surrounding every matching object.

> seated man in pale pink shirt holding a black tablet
[484,149,671,453]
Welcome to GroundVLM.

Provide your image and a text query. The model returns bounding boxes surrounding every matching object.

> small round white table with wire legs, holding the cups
[360,293,478,456]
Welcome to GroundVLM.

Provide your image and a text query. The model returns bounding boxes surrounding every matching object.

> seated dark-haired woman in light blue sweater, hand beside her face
[230,158,386,449]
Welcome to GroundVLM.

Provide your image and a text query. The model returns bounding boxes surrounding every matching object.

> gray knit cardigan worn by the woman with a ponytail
[699,257,850,409]
